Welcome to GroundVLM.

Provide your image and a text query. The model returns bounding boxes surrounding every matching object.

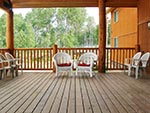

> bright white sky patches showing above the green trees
[0,7,99,24]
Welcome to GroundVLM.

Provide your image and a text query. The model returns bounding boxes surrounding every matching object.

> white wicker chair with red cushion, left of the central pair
[52,52,73,76]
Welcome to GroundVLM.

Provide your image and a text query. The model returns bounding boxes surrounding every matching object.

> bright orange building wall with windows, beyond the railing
[111,8,137,47]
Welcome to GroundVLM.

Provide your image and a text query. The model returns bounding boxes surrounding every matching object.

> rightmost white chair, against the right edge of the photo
[131,52,150,79]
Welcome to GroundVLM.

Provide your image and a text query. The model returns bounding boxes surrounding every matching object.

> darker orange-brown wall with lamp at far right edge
[138,0,150,52]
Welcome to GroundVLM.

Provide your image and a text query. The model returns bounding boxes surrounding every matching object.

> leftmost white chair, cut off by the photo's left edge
[0,53,14,79]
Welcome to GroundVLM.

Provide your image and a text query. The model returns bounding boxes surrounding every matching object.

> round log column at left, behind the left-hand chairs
[6,10,14,53]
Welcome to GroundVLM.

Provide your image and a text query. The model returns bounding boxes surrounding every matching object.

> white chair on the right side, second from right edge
[124,52,142,76]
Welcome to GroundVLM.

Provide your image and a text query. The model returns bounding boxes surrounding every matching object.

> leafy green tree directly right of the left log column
[14,14,35,48]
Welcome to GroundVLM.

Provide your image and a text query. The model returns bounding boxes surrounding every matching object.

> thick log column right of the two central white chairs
[98,0,106,73]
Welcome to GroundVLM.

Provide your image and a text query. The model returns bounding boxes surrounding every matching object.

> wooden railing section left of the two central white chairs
[14,48,53,70]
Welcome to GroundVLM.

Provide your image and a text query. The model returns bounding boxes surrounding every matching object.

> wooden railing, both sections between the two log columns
[14,48,98,70]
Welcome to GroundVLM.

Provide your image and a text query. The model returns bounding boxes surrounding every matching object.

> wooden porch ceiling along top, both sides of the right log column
[9,0,138,8]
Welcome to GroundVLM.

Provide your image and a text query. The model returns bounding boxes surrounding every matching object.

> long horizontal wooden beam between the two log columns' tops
[12,0,98,8]
